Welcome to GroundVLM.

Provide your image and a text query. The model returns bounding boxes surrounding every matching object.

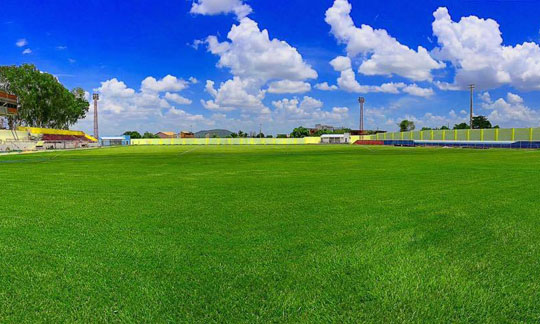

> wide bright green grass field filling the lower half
[0,146,540,323]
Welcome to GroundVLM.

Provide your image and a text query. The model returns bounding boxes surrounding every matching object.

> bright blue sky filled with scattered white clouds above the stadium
[0,0,540,134]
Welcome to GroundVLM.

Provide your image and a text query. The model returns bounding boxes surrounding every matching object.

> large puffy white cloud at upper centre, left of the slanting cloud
[207,18,317,82]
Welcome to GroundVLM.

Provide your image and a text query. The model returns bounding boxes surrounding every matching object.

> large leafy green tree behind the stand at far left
[0,64,89,129]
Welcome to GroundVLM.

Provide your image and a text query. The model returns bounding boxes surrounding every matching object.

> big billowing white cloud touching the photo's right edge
[432,8,540,90]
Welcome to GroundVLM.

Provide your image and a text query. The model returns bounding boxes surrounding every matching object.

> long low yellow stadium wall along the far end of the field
[131,137,321,145]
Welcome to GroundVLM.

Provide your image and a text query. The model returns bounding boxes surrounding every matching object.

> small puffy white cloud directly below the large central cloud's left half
[201,77,269,114]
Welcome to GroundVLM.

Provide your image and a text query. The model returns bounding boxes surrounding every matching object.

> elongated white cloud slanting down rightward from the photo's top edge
[325,0,445,81]
